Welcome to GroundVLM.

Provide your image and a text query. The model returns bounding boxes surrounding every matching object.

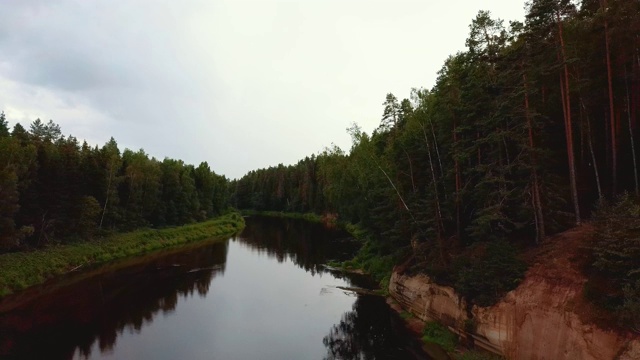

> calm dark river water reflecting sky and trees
[0,217,426,360]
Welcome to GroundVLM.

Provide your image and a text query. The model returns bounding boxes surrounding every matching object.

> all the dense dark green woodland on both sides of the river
[0,0,640,328]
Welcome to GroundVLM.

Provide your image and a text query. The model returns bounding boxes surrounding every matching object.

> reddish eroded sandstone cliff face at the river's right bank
[389,230,640,360]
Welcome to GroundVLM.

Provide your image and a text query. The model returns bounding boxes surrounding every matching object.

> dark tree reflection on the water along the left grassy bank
[0,241,228,359]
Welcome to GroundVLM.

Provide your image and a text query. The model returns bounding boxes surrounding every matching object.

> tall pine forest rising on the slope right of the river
[231,0,640,316]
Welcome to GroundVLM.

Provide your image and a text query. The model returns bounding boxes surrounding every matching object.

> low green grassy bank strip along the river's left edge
[0,213,244,297]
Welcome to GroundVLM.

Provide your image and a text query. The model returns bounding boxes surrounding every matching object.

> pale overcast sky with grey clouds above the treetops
[0,0,524,178]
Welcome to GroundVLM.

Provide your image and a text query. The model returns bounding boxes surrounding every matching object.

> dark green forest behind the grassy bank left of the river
[0,113,229,253]
